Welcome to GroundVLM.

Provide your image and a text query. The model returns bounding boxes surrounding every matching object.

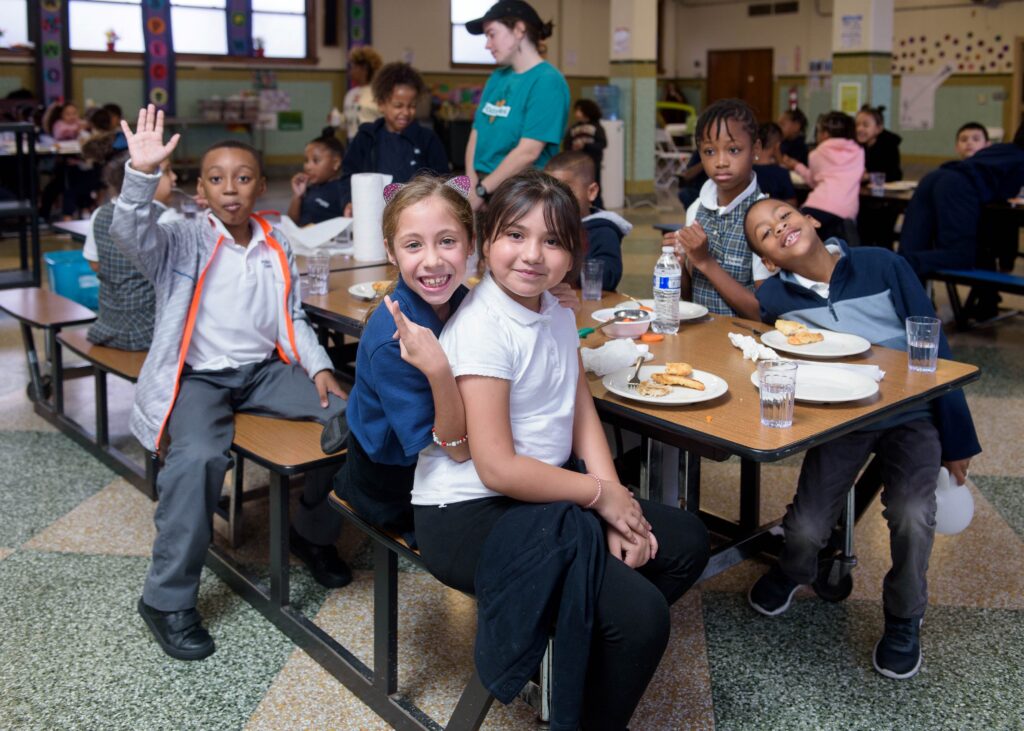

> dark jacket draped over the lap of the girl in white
[474,502,608,731]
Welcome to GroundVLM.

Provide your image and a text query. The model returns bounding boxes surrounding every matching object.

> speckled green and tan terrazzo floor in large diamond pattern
[0,196,1024,730]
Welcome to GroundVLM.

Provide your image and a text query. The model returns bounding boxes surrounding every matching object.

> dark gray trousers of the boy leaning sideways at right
[778,419,942,618]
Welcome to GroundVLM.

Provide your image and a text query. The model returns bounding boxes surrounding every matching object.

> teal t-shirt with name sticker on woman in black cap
[473,61,569,173]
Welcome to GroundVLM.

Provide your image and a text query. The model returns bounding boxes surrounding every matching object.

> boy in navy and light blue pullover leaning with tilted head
[745,199,981,679]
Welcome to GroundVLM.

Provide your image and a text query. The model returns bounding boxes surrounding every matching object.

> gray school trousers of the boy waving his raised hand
[142,357,347,611]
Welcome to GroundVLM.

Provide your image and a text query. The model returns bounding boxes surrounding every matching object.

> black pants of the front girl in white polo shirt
[414,498,710,729]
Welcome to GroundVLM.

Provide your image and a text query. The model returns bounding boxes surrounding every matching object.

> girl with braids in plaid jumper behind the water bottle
[662,99,761,319]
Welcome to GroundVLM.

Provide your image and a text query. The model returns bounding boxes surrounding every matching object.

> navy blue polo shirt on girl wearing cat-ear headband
[346,277,468,465]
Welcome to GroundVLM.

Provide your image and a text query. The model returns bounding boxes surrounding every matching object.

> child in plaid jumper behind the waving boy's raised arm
[82,151,183,350]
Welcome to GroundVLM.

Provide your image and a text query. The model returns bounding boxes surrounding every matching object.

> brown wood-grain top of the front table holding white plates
[578,294,980,462]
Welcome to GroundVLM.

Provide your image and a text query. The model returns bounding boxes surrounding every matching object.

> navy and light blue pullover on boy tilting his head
[757,239,981,460]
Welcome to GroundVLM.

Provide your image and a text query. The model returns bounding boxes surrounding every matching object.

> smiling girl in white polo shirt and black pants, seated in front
[413,170,708,729]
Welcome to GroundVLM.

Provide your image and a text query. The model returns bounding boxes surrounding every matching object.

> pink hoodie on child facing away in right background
[795,137,864,218]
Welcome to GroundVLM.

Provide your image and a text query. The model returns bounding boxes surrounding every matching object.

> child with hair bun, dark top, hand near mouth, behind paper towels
[288,127,345,226]
